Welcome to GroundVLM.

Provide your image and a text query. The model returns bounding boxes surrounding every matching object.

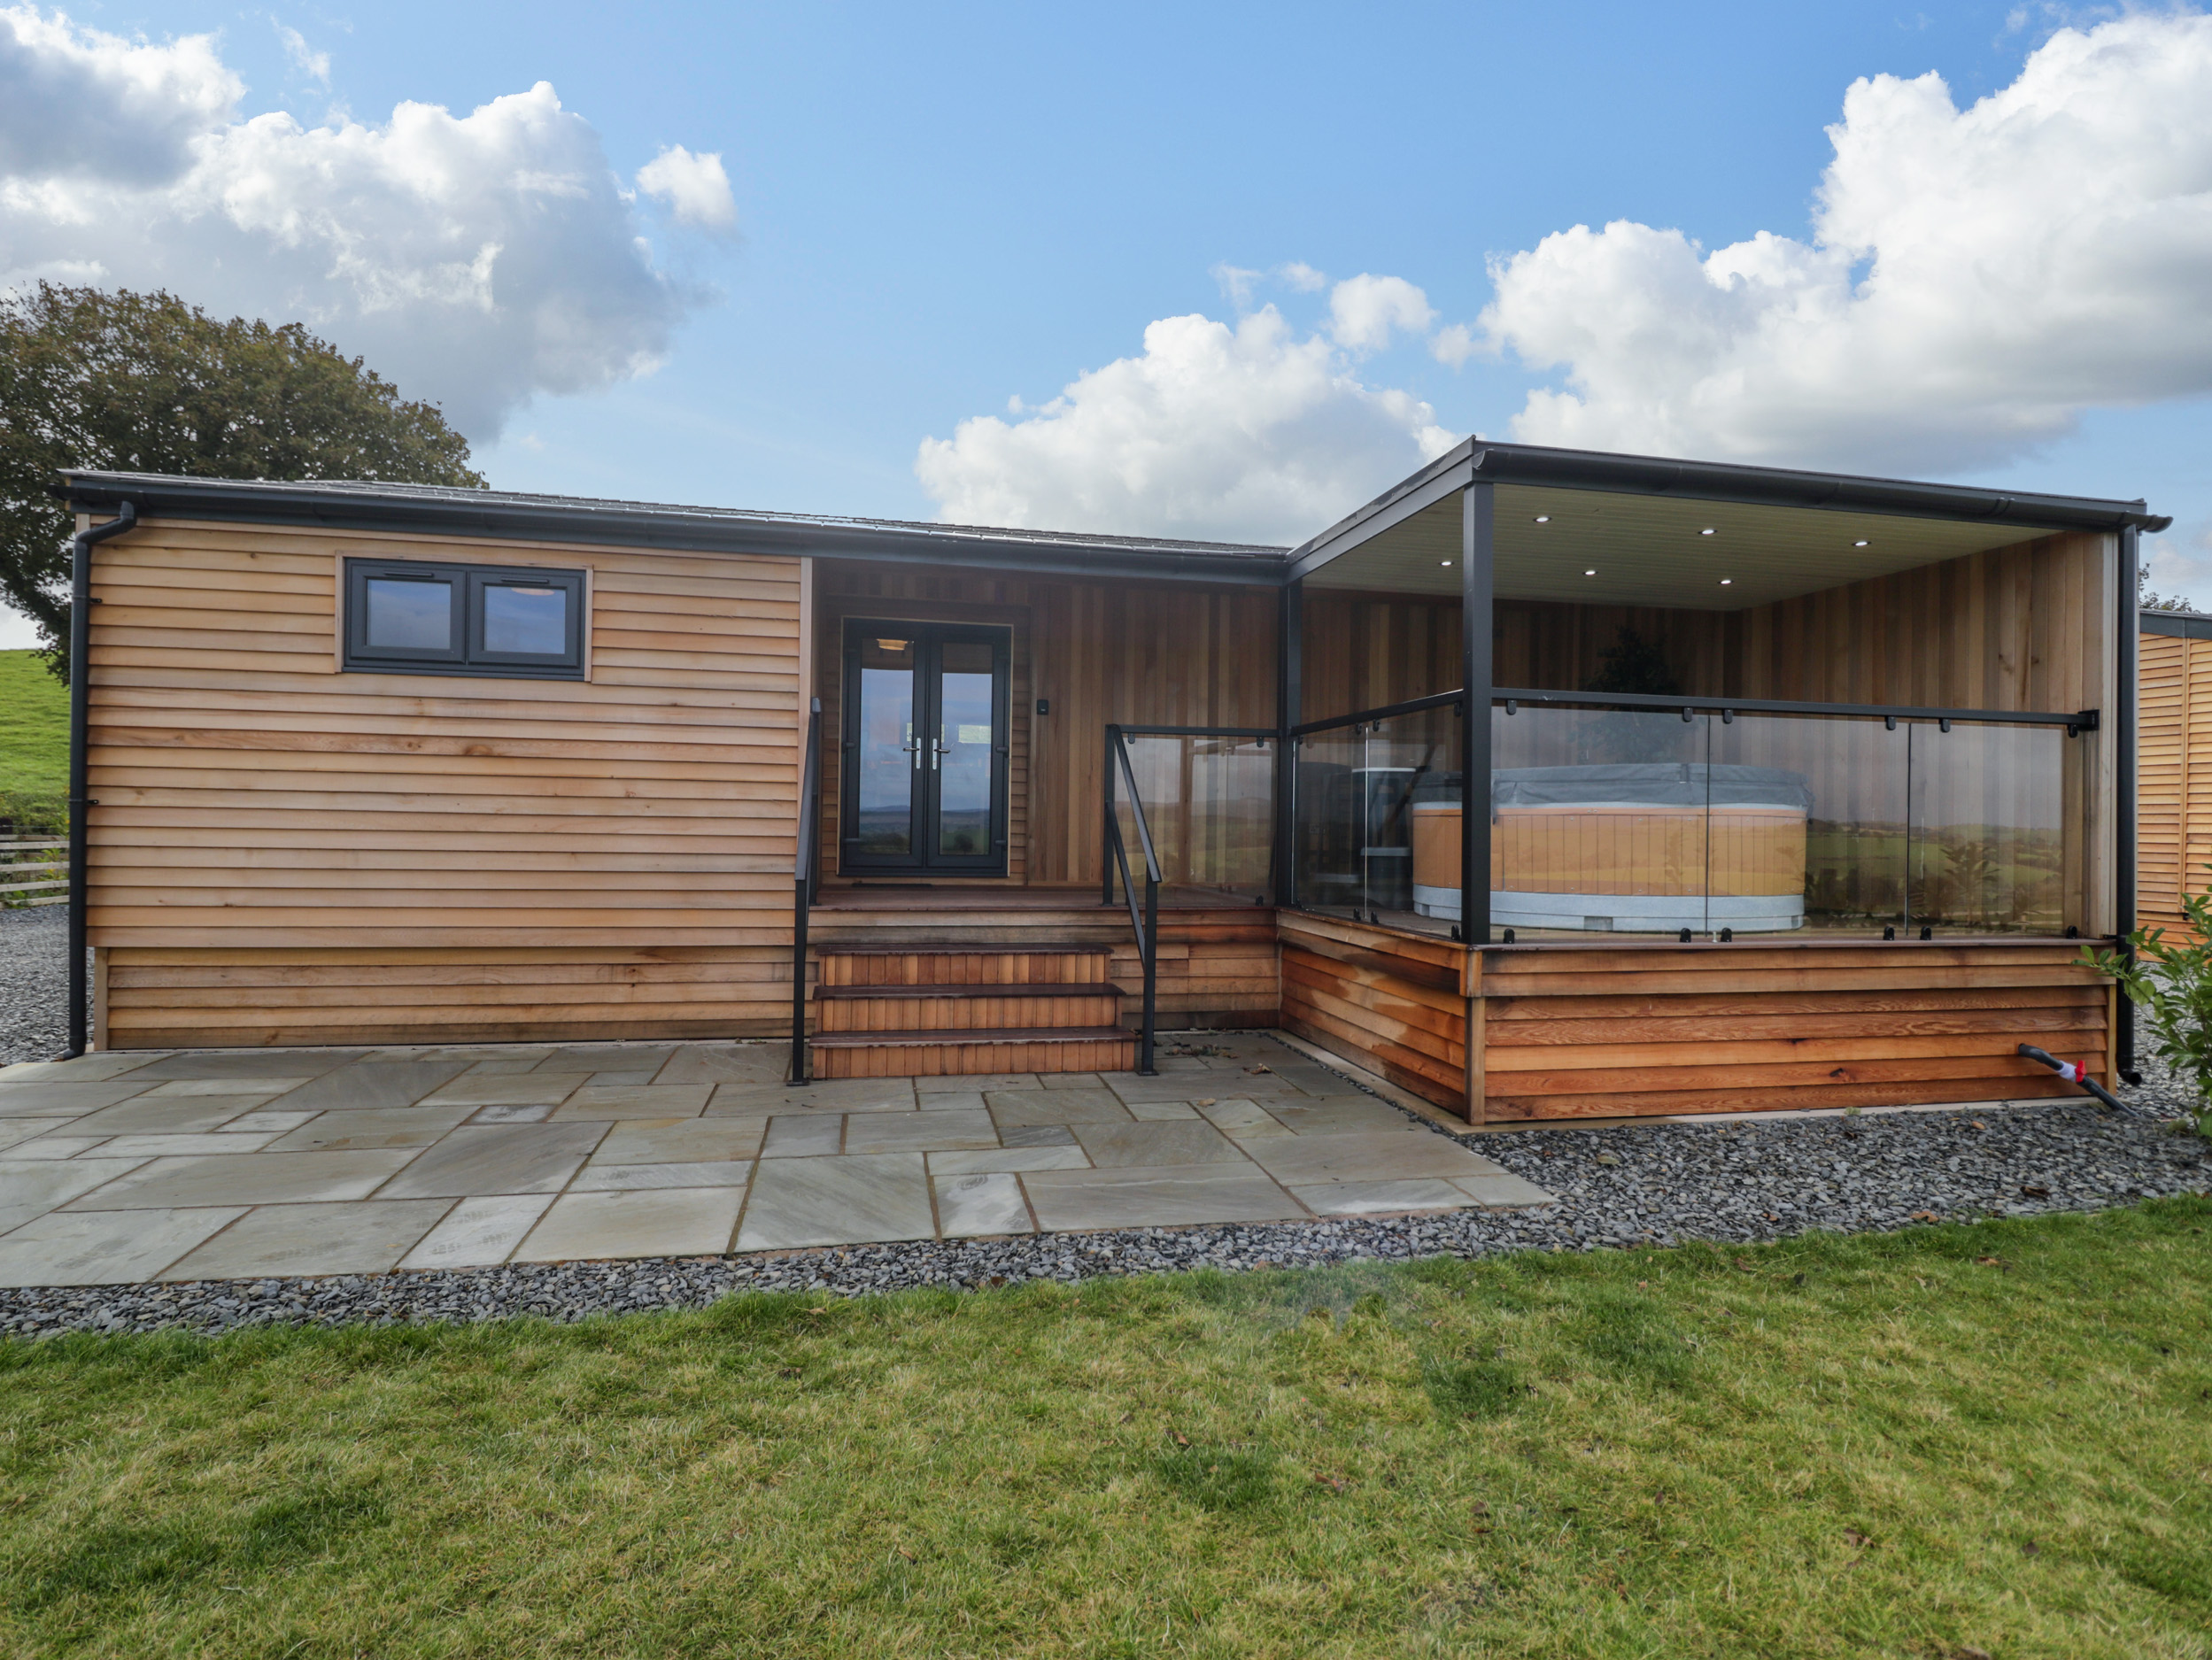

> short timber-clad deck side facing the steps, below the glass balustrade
[1279,911,1469,1114]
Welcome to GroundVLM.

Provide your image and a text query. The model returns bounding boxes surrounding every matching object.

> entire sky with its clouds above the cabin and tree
[0,0,2212,645]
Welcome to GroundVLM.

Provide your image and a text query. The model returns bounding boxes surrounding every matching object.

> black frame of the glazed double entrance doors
[839,617,1013,877]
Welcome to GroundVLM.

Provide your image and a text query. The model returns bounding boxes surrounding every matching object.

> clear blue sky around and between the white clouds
[0,0,2212,644]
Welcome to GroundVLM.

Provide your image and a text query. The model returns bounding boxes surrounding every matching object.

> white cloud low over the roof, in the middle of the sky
[914,305,1453,542]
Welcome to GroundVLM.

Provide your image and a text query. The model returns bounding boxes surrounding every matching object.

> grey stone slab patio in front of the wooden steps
[0,1034,1551,1286]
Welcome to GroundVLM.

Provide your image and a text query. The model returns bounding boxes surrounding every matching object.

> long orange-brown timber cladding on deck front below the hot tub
[1480,942,2113,1123]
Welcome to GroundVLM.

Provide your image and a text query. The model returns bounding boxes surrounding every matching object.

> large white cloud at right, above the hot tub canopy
[1477,13,2212,473]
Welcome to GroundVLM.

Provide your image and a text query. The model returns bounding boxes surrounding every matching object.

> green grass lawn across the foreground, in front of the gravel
[0,1201,2212,1660]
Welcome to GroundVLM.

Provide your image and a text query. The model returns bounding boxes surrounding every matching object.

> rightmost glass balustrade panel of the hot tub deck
[1911,722,2082,933]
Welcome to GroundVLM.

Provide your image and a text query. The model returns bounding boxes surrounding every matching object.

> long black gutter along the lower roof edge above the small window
[55,473,1283,586]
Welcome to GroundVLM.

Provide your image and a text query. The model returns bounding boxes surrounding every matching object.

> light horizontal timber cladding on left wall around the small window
[89,521,805,1047]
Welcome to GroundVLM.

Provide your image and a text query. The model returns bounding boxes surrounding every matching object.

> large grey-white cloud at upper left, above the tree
[0,6,728,444]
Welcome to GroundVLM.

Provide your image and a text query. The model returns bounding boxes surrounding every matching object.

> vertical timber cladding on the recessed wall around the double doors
[814,560,1276,886]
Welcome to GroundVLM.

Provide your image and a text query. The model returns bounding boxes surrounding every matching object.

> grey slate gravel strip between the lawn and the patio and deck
[0,1043,2212,1337]
